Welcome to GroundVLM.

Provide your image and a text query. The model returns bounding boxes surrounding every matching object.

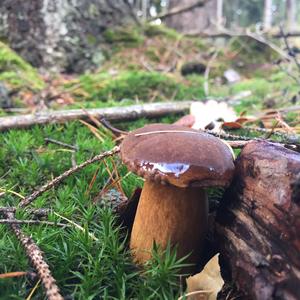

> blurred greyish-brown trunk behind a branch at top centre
[165,0,217,33]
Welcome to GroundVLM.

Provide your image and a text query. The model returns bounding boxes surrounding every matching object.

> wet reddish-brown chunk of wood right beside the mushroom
[216,141,300,300]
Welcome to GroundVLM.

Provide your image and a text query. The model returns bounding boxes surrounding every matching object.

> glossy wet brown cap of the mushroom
[120,124,234,187]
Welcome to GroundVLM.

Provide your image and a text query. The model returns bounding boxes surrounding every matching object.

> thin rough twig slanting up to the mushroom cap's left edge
[19,146,120,207]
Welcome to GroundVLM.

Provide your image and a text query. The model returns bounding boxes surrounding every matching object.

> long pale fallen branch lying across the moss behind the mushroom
[0,101,191,131]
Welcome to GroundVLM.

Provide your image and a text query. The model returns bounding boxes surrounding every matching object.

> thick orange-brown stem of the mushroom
[130,180,208,264]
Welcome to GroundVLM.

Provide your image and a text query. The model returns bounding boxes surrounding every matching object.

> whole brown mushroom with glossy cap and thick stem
[120,124,234,264]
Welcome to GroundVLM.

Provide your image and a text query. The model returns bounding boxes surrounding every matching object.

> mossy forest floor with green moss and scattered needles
[0,26,300,299]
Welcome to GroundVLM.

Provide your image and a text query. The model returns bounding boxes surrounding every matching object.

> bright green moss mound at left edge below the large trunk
[0,42,44,90]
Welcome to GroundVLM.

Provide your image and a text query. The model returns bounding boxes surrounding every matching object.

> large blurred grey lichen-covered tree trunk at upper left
[0,0,134,72]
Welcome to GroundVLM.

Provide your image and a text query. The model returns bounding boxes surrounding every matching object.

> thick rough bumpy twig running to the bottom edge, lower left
[6,213,63,300]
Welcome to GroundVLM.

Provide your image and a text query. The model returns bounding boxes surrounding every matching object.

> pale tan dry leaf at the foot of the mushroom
[186,254,224,300]
